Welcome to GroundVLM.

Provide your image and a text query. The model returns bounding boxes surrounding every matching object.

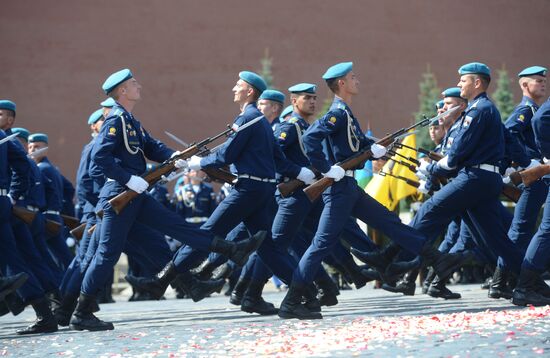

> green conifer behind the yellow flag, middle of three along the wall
[414,64,441,149]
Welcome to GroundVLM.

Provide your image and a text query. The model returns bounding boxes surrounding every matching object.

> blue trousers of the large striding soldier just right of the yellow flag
[411,168,521,272]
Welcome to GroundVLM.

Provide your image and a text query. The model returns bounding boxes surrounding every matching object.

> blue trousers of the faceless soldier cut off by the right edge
[521,178,550,272]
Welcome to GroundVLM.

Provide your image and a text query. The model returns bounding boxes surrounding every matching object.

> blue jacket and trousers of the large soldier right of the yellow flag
[411,86,521,270]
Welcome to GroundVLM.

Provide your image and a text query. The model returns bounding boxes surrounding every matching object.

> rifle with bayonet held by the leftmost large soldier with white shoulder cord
[108,116,264,216]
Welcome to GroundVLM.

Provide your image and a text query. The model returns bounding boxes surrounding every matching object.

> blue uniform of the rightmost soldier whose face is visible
[505,84,548,252]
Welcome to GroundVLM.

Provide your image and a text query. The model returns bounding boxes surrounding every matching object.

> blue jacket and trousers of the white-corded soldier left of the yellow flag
[292,97,425,285]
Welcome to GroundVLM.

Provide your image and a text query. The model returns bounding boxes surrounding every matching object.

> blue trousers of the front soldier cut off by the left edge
[0,196,44,303]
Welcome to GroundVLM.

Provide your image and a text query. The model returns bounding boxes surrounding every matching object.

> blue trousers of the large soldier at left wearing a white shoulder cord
[82,193,212,295]
